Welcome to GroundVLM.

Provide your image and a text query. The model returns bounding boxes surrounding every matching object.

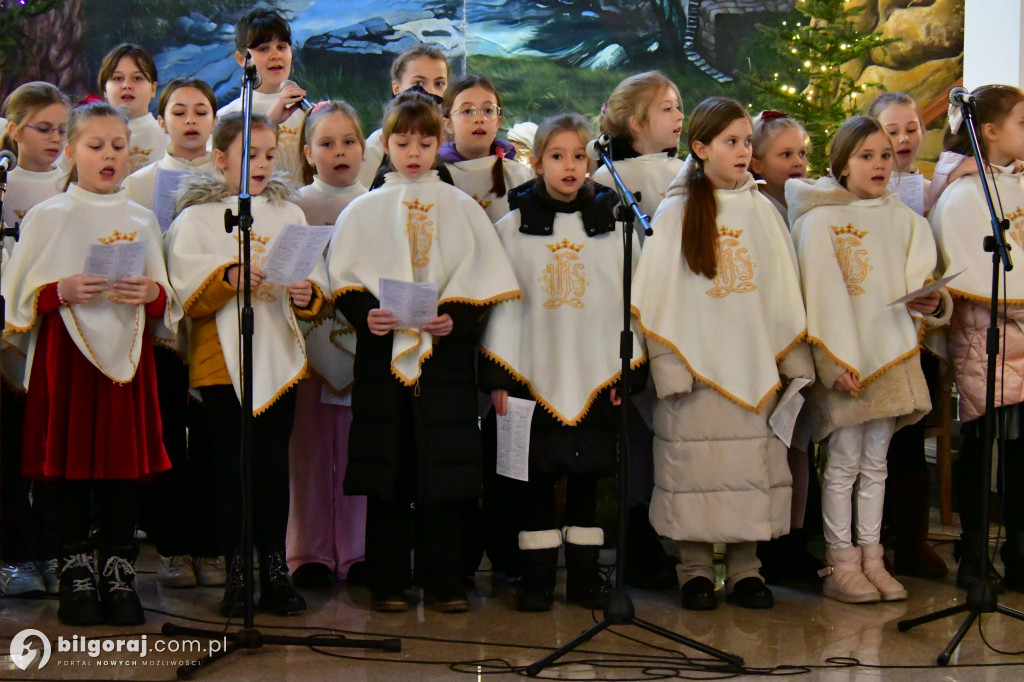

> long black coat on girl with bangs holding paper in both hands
[335,292,487,503]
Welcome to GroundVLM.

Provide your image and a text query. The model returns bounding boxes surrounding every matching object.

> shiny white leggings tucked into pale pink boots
[821,417,896,549]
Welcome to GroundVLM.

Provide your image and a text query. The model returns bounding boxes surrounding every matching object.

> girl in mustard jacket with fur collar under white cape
[167,114,327,616]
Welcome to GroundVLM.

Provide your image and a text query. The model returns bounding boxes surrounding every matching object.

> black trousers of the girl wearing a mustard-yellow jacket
[200,386,295,555]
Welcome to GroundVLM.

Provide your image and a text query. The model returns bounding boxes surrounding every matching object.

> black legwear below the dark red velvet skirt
[54,478,141,548]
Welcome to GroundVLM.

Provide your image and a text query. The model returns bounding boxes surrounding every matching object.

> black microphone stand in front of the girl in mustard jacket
[161,53,401,679]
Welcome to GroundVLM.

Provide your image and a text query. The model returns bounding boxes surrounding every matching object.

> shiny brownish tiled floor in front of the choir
[0,516,1024,682]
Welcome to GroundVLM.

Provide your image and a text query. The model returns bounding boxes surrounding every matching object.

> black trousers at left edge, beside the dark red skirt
[0,382,60,563]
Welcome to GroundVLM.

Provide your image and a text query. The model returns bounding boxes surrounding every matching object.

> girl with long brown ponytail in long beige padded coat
[634,97,814,609]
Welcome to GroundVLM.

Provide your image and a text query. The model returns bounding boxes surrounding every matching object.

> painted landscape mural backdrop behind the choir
[0,0,964,162]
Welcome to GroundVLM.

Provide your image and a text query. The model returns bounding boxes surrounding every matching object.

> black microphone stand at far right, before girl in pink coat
[897,95,1024,666]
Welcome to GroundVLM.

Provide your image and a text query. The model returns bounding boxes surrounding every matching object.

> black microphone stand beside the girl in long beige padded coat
[526,135,743,677]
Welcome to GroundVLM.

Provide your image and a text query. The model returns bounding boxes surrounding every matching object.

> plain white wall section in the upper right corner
[964,0,1024,89]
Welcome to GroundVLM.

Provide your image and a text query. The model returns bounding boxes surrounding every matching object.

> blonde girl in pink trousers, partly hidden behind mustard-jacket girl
[288,99,367,588]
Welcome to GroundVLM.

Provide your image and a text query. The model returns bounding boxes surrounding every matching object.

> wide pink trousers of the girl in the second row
[287,379,367,580]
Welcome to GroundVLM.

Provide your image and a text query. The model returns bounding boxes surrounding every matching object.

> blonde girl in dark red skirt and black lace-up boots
[2,98,180,626]
